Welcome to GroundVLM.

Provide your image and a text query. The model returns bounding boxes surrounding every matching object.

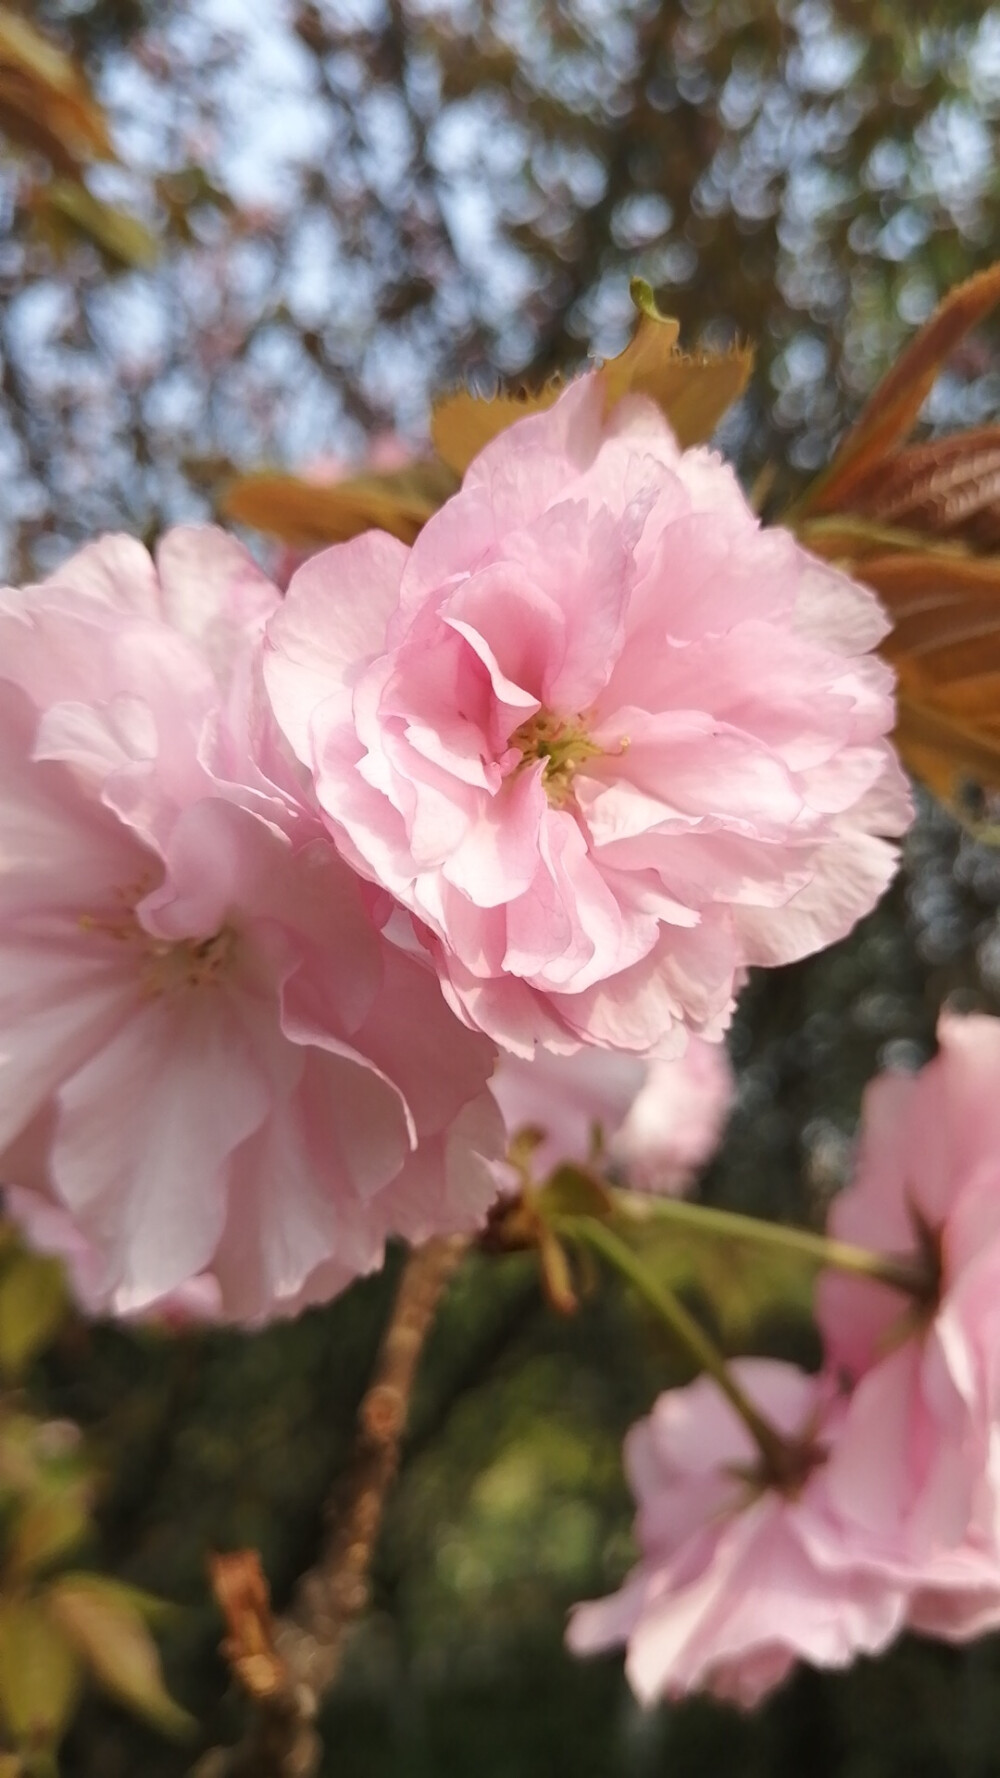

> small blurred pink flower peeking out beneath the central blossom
[491,1037,733,1191]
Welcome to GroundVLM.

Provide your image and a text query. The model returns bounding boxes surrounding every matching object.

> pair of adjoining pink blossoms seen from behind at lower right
[569,1015,1000,1705]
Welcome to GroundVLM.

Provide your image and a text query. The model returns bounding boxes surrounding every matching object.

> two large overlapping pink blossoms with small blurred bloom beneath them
[0,375,909,1321]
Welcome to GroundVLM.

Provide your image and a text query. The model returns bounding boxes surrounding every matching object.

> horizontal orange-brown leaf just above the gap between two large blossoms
[219,461,456,549]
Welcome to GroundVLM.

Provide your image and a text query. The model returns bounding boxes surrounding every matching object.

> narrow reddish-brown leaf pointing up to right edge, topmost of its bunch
[801,263,1000,512]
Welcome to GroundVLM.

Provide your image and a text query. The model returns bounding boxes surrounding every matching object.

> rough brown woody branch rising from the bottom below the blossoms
[192,1236,468,1778]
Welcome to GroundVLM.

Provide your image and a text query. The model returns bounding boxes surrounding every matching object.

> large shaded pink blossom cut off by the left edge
[0,530,502,1319]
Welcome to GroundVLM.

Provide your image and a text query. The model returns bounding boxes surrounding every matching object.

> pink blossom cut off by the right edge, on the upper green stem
[817,1013,1000,1614]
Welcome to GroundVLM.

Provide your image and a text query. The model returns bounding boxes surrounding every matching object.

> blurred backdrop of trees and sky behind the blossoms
[0,0,1000,1778]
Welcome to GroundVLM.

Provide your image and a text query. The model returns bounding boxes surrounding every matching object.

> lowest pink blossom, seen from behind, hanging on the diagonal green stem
[568,1358,906,1707]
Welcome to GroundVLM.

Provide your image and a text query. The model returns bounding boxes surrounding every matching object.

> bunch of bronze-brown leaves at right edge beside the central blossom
[790,263,1000,809]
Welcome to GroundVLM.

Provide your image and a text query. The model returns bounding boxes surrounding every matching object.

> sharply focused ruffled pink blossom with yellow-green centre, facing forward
[265,375,909,1056]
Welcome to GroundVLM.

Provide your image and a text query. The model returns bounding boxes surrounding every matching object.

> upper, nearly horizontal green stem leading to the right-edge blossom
[607,1188,934,1296]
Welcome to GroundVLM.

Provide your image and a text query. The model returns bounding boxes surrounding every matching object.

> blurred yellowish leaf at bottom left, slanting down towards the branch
[44,1574,192,1735]
